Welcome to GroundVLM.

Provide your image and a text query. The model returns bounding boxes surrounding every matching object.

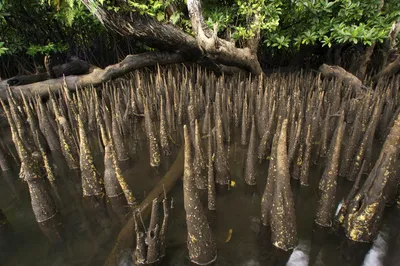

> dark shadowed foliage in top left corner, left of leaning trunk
[0,0,104,56]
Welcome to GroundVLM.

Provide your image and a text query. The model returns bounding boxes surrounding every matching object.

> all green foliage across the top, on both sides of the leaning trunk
[0,0,400,75]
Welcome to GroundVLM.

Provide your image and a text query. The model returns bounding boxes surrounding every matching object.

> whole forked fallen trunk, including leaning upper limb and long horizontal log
[0,0,262,100]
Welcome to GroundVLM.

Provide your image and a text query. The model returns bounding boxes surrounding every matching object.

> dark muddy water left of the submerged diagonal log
[0,128,176,266]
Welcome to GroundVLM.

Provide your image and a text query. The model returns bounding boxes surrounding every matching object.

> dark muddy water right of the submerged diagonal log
[163,131,400,266]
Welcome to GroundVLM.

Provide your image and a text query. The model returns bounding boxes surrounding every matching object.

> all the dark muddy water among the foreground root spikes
[0,128,400,266]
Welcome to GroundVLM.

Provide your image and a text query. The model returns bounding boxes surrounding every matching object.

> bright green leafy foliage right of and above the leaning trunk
[116,0,400,50]
